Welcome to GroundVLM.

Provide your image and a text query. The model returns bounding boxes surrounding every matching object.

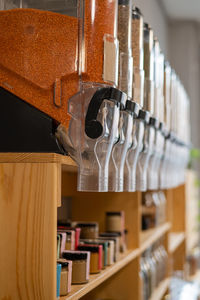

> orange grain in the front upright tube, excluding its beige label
[82,0,117,83]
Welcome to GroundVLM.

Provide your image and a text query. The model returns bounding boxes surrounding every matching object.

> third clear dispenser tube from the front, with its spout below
[124,7,144,192]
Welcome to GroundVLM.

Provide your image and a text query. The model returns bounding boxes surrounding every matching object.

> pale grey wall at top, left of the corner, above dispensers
[133,0,169,58]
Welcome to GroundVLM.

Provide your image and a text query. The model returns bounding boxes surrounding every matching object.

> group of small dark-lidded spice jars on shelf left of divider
[57,211,128,296]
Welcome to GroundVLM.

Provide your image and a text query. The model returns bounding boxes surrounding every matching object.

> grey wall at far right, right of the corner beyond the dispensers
[169,21,200,154]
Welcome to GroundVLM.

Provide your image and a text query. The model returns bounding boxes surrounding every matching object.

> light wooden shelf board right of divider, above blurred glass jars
[140,222,171,252]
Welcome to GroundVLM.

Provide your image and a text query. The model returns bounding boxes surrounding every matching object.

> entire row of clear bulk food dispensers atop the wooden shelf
[0,0,190,192]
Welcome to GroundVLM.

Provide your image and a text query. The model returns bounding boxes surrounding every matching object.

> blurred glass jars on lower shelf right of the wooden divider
[140,242,168,300]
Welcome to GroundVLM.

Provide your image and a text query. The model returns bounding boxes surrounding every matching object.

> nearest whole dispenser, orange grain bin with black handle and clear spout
[0,0,127,191]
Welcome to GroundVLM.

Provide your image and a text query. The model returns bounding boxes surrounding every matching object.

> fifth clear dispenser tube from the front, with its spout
[148,38,165,190]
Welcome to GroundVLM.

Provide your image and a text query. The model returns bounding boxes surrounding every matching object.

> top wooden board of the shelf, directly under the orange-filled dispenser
[0,152,77,170]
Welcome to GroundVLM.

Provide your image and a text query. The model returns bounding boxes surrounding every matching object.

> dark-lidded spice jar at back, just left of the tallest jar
[76,222,99,239]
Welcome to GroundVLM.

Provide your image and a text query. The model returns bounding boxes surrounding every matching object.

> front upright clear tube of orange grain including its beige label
[82,0,118,85]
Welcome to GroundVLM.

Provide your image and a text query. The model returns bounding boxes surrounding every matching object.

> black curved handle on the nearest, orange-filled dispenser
[85,87,127,139]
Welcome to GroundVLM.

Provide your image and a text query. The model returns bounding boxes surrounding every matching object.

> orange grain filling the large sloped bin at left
[0,8,79,127]
